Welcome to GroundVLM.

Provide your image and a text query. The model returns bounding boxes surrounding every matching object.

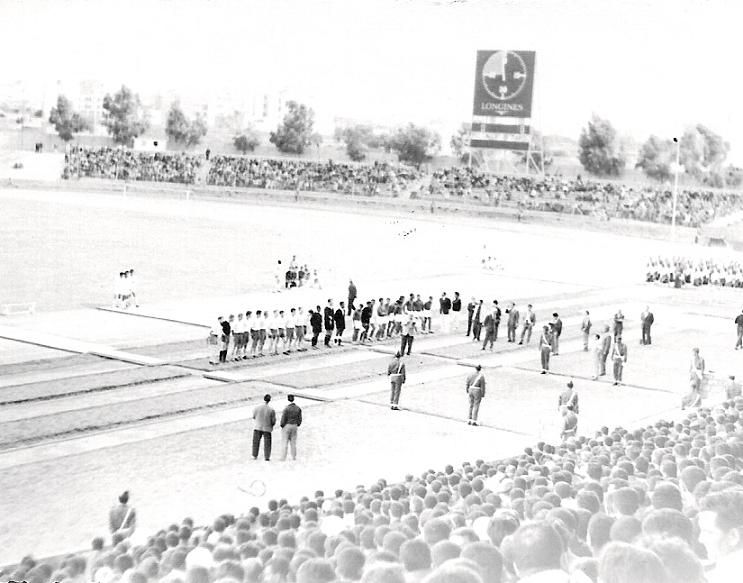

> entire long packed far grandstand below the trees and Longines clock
[63,147,743,227]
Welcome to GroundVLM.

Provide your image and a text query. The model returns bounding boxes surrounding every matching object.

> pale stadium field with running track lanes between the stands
[0,190,743,563]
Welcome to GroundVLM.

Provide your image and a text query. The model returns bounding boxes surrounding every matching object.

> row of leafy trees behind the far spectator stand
[49,86,743,186]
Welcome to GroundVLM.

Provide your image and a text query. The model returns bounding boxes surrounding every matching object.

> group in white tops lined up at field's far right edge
[645,257,743,287]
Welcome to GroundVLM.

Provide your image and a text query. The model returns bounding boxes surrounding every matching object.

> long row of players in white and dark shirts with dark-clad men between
[207,294,442,364]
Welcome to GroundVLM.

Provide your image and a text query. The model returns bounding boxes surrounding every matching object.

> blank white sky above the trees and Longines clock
[0,0,743,164]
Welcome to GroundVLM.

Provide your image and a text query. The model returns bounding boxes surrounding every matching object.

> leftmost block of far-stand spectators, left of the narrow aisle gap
[62,146,202,184]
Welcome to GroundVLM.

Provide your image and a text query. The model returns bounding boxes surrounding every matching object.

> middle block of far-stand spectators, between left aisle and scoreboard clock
[207,156,421,196]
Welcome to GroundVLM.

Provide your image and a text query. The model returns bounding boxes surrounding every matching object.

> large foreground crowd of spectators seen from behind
[3,397,743,583]
